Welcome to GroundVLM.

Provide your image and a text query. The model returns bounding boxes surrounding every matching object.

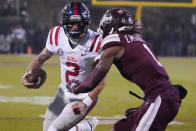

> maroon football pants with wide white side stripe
[114,88,180,131]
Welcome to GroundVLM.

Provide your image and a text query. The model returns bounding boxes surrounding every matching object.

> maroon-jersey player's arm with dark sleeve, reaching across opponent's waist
[73,46,124,94]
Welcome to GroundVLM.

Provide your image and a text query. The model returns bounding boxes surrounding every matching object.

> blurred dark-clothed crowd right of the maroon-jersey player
[144,23,196,56]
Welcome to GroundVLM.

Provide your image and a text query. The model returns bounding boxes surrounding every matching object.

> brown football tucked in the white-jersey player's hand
[26,68,47,88]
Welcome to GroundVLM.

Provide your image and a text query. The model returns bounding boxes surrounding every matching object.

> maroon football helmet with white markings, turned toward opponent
[98,9,134,37]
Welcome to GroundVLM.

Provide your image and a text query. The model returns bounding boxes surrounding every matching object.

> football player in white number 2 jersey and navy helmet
[22,2,105,131]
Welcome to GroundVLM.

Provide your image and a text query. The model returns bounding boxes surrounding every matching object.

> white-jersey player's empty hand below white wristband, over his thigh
[72,102,86,115]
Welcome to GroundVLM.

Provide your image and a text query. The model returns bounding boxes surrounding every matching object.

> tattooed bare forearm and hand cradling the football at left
[21,48,53,87]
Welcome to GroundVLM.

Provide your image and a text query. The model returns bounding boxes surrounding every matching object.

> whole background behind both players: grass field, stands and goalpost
[0,0,196,131]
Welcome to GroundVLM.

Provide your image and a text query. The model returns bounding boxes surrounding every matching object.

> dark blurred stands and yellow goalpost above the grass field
[0,0,196,56]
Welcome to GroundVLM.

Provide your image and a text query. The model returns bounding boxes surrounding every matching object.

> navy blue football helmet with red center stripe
[60,2,90,39]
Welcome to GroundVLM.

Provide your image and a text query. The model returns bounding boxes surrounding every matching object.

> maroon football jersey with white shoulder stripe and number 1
[103,34,170,94]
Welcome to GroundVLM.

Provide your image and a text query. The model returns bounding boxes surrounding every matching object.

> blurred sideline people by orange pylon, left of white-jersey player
[0,22,48,54]
